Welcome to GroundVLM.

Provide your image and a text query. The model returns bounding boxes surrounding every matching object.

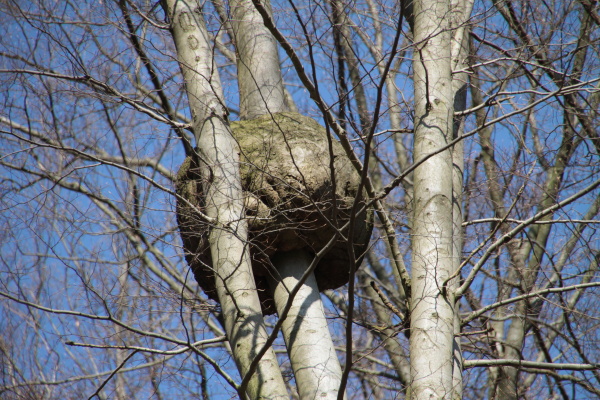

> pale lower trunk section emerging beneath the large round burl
[272,251,345,400]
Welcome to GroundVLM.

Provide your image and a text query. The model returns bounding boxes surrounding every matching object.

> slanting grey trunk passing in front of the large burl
[166,0,288,399]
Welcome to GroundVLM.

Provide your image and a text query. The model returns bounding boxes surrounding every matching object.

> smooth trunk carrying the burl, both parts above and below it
[231,0,345,400]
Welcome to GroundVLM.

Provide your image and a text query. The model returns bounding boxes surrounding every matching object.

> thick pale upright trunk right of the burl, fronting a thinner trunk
[410,0,455,399]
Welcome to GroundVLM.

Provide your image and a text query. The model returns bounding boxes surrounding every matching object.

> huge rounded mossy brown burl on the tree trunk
[177,112,373,314]
